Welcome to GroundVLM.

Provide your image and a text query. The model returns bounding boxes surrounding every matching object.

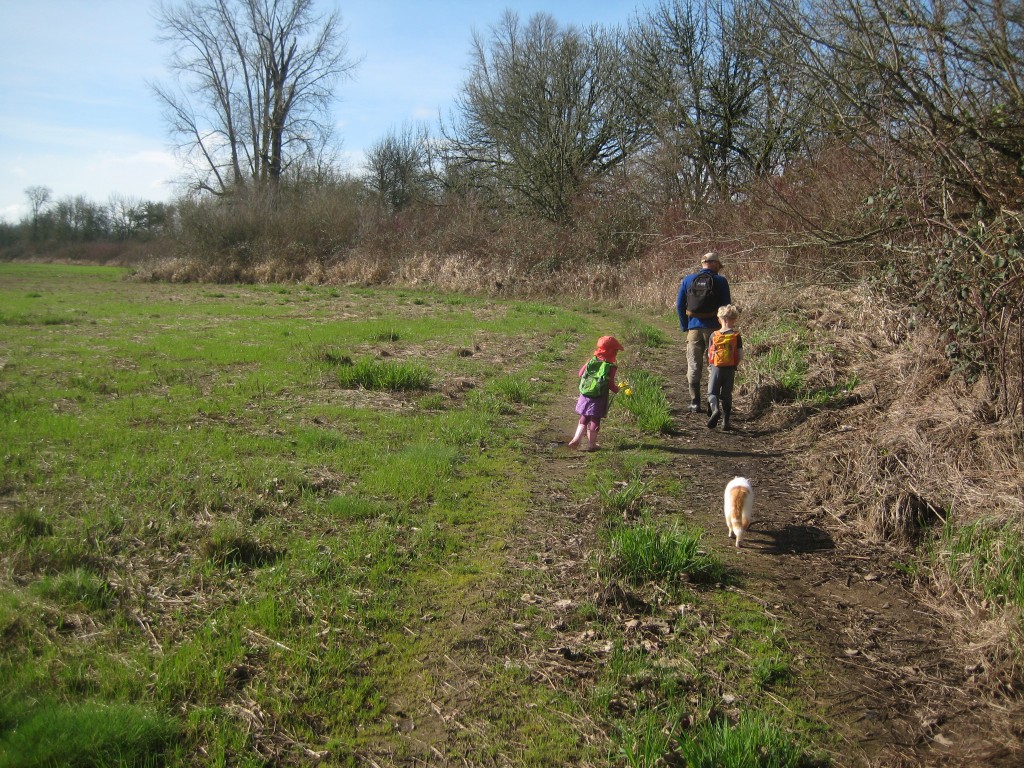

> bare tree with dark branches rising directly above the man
[628,0,819,212]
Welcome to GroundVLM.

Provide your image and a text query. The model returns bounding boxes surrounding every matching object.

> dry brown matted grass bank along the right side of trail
[752,286,1024,689]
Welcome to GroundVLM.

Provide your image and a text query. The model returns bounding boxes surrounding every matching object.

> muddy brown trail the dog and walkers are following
[493,352,1024,767]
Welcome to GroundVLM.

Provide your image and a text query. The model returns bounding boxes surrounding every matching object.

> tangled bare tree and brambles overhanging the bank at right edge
[765,0,1024,418]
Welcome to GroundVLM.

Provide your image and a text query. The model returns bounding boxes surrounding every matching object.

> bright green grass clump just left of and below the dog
[611,520,725,584]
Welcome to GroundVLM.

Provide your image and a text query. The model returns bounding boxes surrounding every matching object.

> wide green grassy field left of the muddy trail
[0,264,820,768]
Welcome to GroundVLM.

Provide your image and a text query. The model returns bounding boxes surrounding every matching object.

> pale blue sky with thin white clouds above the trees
[0,0,655,221]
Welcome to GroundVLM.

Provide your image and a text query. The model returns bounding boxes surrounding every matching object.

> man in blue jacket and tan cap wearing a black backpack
[676,251,732,414]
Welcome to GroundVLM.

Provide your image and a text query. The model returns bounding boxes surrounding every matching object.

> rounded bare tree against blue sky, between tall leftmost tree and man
[445,11,638,222]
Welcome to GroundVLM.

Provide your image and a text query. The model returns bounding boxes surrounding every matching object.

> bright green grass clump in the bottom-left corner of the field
[0,700,179,768]
